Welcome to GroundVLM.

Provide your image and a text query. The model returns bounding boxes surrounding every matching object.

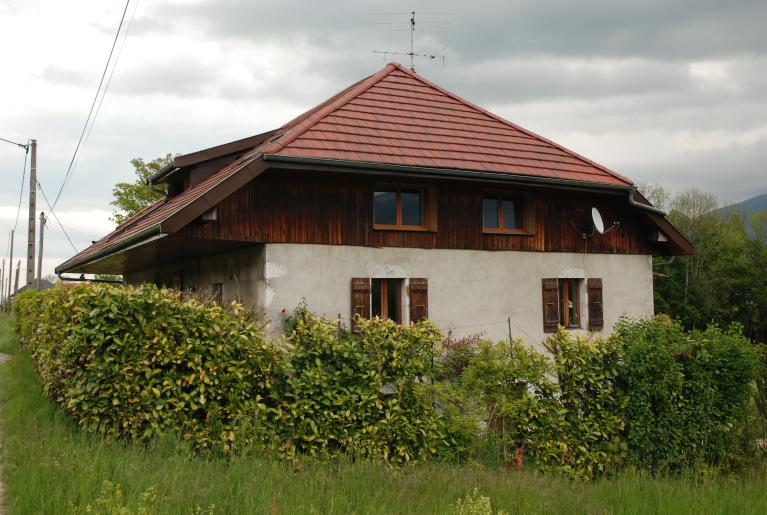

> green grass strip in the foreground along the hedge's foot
[0,317,767,514]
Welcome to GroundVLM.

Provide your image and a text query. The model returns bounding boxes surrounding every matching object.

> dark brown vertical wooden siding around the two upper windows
[179,170,658,254]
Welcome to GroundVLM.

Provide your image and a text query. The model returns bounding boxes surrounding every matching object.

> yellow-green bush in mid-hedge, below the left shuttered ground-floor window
[280,309,462,463]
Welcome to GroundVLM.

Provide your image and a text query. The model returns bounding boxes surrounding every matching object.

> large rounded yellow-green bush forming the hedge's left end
[15,285,280,451]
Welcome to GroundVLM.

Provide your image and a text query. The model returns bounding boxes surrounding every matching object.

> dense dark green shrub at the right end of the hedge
[613,319,758,472]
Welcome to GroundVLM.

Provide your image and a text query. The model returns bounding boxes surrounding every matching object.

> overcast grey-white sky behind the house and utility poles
[0,0,767,283]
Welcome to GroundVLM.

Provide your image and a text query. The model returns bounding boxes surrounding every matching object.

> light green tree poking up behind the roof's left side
[110,154,174,224]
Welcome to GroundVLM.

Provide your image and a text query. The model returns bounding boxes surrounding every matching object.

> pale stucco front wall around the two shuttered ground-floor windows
[260,244,653,344]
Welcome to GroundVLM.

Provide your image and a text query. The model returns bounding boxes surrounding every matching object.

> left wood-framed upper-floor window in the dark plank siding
[373,188,429,230]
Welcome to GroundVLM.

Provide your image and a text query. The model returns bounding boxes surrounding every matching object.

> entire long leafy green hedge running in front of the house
[14,286,758,479]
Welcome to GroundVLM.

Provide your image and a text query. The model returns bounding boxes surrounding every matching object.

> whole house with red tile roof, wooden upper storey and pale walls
[56,63,692,342]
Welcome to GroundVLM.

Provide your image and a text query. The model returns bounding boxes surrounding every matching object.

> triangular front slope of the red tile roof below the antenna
[263,63,633,186]
